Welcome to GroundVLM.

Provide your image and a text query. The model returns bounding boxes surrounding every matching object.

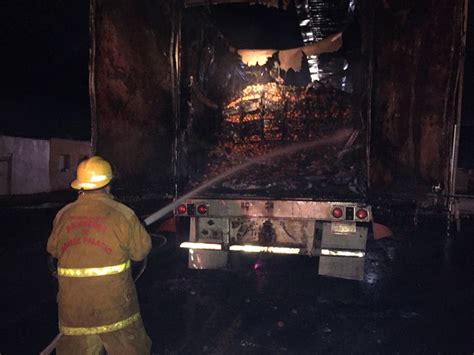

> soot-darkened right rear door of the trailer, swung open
[372,0,466,193]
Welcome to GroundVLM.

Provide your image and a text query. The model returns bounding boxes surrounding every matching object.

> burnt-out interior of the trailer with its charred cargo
[178,2,367,198]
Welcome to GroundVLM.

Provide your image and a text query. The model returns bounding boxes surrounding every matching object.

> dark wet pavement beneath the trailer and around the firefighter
[0,196,474,355]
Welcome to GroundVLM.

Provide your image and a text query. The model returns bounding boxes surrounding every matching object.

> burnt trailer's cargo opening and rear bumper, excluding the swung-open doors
[170,3,372,280]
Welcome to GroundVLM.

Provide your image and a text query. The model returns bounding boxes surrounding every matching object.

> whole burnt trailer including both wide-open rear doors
[90,0,467,279]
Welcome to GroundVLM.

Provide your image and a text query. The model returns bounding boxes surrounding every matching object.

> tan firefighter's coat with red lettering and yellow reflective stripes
[47,192,151,335]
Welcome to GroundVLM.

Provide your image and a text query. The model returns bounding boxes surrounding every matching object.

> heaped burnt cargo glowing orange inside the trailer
[187,83,366,199]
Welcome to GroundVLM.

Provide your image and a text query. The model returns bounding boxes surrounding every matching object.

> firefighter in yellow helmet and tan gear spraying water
[47,156,151,355]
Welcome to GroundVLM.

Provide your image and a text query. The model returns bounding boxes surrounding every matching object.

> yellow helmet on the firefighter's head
[71,155,113,190]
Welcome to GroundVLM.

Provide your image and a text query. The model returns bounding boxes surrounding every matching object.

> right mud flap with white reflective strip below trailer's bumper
[318,223,368,280]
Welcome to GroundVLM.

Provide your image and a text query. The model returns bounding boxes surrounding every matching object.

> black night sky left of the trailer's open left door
[0,0,90,139]
